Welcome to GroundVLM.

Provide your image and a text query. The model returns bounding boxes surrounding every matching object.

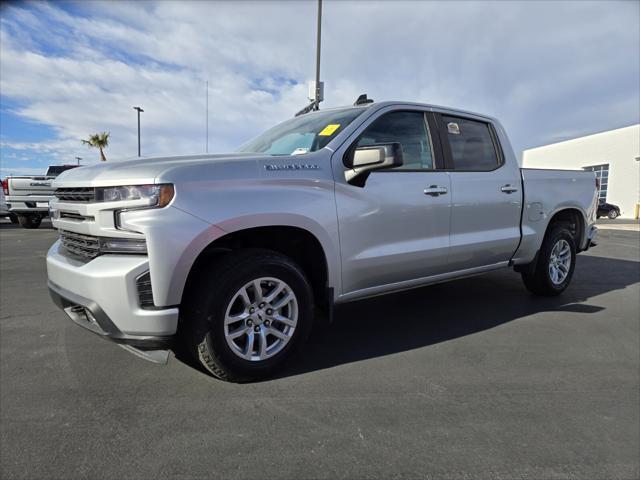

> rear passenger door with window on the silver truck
[436,114,522,271]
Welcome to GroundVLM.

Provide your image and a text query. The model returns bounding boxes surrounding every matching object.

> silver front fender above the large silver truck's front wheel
[168,176,342,302]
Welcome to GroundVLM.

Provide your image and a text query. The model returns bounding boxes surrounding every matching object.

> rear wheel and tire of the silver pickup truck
[522,225,576,297]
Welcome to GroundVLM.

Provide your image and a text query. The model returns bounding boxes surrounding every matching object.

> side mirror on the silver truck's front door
[344,142,402,187]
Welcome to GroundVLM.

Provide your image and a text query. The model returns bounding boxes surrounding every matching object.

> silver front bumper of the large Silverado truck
[47,241,179,338]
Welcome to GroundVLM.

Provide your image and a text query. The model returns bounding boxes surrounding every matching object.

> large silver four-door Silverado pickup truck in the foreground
[47,102,597,381]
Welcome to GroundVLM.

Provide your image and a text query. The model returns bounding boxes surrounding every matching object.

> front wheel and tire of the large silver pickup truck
[183,249,314,382]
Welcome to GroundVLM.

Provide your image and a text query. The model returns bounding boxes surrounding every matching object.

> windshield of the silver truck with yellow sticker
[238,107,366,155]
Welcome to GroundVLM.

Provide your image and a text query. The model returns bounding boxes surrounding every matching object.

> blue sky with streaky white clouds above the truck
[0,0,640,176]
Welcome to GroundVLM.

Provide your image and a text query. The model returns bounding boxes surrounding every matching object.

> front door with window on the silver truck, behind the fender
[334,110,451,294]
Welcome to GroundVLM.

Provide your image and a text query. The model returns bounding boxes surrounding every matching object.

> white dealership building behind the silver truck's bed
[522,124,640,218]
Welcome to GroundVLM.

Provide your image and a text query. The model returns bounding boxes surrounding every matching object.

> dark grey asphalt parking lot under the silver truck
[0,219,640,479]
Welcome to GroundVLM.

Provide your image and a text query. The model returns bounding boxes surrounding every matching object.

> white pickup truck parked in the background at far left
[2,165,78,228]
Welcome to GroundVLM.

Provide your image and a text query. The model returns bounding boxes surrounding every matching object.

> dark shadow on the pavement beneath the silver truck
[278,255,640,378]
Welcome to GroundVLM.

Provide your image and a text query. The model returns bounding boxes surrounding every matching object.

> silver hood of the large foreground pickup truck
[53,153,262,188]
